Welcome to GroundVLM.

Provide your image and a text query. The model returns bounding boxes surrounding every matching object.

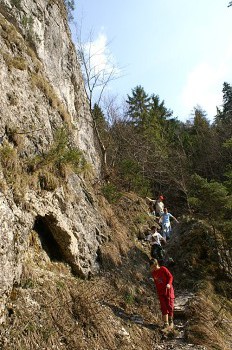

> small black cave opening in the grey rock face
[33,216,64,262]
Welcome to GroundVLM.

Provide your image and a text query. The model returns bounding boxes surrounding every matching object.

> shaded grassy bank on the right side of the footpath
[167,217,232,349]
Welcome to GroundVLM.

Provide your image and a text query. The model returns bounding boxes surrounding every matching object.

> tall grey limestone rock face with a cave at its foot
[0,0,106,321]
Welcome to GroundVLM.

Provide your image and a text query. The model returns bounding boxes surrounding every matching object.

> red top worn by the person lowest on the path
[152,266,175,298]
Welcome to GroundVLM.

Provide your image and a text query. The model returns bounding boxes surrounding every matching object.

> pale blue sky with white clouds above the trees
[74,0,232,121]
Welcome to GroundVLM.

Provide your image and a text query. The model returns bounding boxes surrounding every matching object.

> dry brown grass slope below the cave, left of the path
[1,227,159,350]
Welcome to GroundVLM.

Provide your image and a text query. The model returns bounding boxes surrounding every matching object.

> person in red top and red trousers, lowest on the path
[150,259,175,329]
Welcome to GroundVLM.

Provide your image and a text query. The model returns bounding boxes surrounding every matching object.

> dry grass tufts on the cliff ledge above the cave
[0,128,89,200]
